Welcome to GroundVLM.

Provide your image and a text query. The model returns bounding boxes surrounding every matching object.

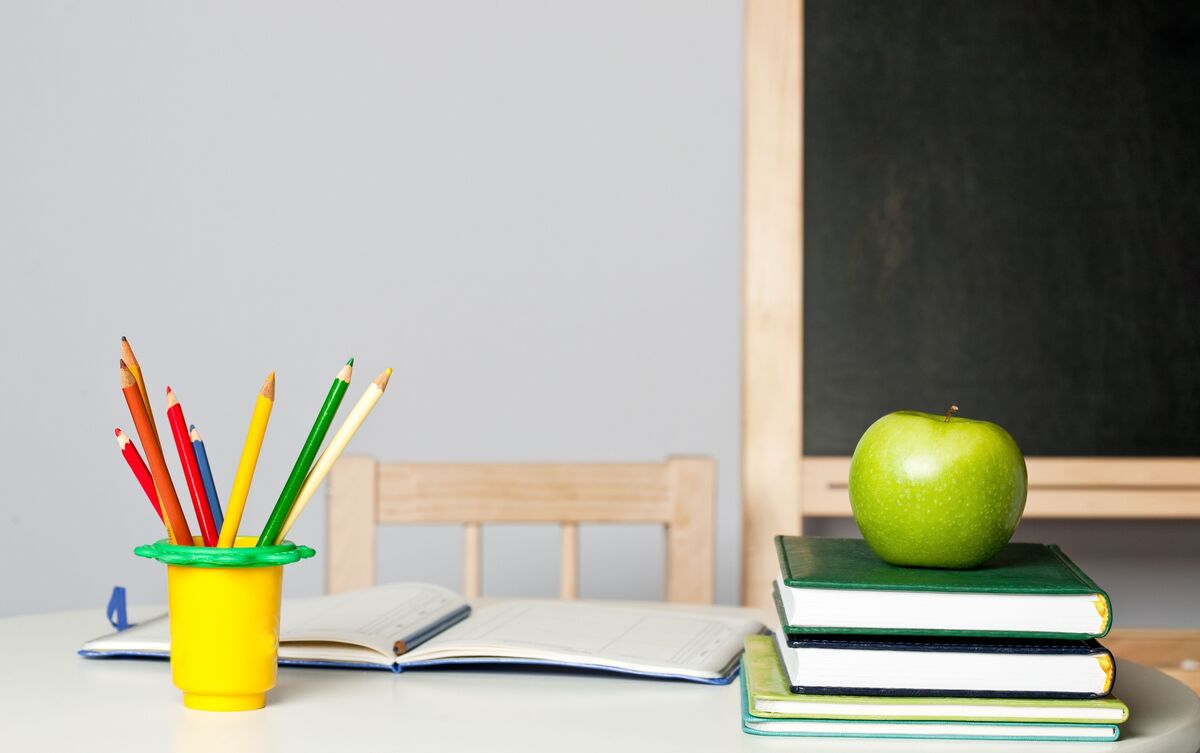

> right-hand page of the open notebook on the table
[397,601,763,677]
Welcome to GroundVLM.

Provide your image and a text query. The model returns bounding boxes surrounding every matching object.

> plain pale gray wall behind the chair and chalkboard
[0,0,1200,625]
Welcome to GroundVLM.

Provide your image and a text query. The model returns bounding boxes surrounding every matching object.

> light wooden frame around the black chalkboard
[742,0,1200,607]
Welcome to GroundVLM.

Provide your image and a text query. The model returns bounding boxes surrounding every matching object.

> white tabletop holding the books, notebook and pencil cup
[0,609,1200,753]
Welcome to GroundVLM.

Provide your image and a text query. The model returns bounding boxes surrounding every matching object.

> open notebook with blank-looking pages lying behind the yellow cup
[79,583,764,685]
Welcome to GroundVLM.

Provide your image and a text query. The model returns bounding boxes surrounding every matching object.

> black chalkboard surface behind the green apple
[803,0,1200,456]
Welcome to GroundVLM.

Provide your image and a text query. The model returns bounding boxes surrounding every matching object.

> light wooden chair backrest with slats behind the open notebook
[325,457,716,603]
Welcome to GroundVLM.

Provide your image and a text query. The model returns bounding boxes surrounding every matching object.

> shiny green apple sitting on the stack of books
[850,406,1027,570]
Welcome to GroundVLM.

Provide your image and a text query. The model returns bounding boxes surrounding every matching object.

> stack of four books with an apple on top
[742,536,1129,741]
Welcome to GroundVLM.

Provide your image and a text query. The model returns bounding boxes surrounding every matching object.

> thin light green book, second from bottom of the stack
[743,635,1129,724]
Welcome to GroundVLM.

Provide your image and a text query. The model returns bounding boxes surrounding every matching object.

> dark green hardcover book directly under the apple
[775,536,1112,639]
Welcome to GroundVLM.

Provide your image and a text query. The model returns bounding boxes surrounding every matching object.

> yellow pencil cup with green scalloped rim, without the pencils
[133,536,313,711]
